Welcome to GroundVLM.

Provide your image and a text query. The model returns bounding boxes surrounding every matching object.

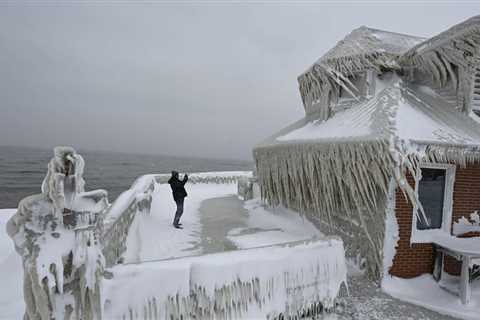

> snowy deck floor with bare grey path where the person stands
[119,175,321,263]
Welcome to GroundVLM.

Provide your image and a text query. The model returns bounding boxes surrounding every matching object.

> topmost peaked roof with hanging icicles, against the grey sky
[298,27,425,118]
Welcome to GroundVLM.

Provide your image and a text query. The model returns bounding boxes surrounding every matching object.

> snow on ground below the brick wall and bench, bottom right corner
[382,274,480,320]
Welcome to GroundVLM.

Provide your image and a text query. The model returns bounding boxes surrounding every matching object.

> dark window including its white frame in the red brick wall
[411,164,455,243]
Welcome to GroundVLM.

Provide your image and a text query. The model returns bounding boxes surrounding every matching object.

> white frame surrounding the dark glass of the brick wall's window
[410,163,456,243]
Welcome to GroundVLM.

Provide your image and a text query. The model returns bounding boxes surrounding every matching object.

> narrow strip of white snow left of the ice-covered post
[0,209,25,319]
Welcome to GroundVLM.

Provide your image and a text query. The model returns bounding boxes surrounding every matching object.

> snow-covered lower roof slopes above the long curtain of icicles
[260,76,480,152]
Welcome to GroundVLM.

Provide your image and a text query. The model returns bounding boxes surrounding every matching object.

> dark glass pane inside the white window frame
[417,168,445,230]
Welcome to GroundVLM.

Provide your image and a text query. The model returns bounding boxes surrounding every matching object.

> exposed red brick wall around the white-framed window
[390,164,480,278]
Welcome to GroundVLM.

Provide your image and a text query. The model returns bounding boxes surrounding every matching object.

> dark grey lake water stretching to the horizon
[0,146,253,208]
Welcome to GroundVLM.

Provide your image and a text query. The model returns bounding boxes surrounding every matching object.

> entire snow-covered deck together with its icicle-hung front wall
[102,176,346,319]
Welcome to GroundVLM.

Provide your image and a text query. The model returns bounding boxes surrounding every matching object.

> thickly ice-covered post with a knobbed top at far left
[7,147,108,320]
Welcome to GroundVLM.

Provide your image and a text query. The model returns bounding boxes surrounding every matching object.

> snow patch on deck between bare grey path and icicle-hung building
[228,198,322,248]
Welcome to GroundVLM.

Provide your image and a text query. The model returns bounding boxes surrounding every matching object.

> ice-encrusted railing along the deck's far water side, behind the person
[101,171,251,267]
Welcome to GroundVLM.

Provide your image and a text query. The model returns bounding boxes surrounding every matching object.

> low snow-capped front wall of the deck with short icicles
[104,238,347,319]
